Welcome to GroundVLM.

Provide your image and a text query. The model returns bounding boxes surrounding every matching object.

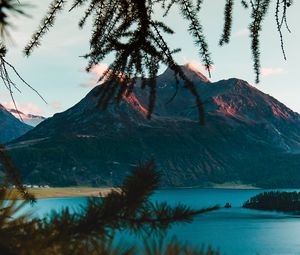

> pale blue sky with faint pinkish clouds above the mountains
[0,0,300,117]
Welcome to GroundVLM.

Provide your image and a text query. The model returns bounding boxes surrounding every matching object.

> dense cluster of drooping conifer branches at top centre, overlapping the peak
[25,0,212,123]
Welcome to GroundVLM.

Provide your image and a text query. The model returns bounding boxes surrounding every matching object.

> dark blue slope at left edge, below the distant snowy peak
[0,104,32,143]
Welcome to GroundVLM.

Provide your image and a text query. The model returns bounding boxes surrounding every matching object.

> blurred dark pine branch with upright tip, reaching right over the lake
[39,161,218,242]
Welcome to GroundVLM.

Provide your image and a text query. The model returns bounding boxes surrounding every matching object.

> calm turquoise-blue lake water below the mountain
[24,189,300,255]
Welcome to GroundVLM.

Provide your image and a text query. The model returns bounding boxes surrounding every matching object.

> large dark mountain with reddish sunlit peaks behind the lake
[4,66,300,187]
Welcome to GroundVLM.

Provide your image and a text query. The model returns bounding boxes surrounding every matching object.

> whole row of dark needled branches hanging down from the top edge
[24,0,293,121]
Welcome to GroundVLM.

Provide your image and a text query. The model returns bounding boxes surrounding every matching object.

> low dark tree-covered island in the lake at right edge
[243,191,300,213]
